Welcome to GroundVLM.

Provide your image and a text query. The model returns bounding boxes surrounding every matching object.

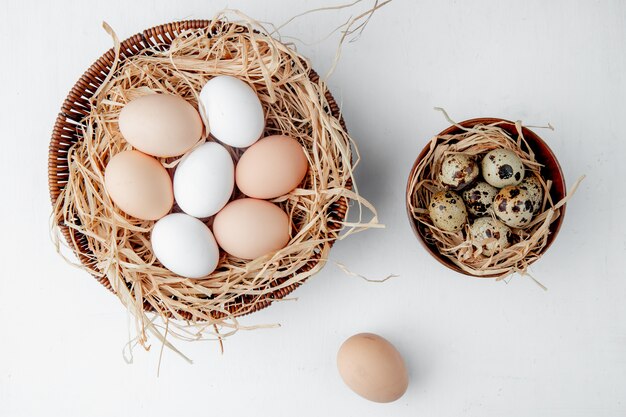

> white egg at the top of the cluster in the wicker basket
[200,75,265,148]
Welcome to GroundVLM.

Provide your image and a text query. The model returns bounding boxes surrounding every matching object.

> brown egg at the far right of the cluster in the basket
[235,135,308,199]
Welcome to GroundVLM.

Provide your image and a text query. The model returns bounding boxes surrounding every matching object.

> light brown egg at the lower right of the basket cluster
[213,198,289,259]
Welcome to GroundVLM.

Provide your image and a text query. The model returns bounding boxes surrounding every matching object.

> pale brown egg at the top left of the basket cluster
[119,94,203,157]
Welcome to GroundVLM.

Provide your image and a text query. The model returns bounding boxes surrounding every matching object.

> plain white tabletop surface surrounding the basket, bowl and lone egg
[0,0,626,417]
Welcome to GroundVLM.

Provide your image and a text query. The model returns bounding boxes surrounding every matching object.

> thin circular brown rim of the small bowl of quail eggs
[405,117,567,278]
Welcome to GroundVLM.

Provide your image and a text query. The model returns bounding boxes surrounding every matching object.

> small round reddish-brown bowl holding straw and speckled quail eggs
[406,117,566,278]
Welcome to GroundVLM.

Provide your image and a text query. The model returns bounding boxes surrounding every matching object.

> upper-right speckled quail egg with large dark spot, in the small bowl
[482,149,524,188]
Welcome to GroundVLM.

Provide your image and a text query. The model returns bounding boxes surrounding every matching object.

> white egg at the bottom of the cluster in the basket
[151,213,220,278]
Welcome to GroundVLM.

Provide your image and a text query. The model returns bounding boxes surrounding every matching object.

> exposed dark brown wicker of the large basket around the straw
[48,20,351,319]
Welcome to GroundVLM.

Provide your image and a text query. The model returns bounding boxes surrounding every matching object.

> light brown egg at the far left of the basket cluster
[104,151,174,220]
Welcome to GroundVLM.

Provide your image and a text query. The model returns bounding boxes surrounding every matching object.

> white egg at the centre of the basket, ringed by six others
[174,142,235,218]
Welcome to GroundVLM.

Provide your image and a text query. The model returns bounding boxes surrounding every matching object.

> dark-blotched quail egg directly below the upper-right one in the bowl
[493,185,533,228]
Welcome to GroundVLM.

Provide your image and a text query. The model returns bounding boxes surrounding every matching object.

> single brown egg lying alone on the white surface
[337,333,409,403]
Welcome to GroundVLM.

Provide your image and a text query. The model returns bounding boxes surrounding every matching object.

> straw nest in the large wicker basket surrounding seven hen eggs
[53,16,377,343]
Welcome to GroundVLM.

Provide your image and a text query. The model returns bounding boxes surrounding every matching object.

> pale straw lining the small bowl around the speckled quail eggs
[407,117,574,279]
